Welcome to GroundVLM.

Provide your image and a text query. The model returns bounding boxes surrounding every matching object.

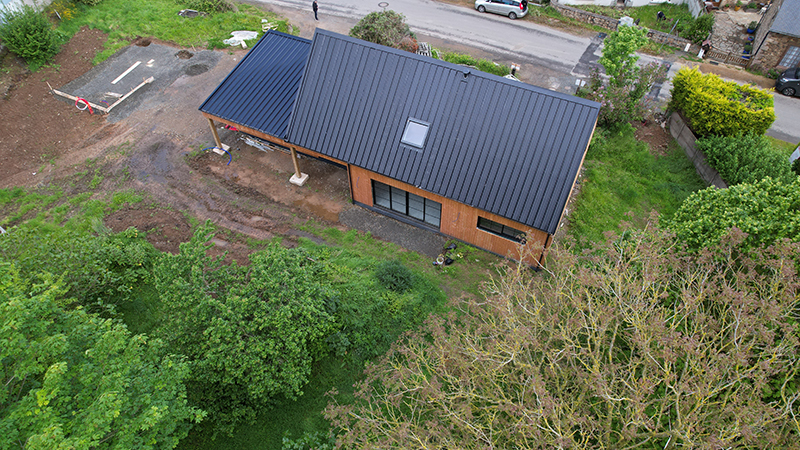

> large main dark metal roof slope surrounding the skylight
[288,28,600,234]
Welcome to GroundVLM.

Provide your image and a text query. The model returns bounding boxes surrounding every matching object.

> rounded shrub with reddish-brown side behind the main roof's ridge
[350,10,418,52]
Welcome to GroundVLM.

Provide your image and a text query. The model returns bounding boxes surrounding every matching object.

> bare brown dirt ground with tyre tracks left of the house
[0,16,684,262]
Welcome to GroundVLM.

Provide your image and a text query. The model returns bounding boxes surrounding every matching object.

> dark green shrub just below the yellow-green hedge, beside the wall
[697,133,795,184]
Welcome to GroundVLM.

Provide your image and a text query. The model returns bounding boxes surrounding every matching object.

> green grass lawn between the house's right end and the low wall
[570,125,706,245]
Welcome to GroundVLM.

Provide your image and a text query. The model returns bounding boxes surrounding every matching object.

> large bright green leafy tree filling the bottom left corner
[0,263,205,450]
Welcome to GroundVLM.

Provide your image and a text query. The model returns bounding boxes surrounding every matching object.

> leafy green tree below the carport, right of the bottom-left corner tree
[155,224,333,431]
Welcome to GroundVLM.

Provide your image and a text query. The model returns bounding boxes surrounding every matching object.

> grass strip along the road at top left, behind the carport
[49,0,288,64]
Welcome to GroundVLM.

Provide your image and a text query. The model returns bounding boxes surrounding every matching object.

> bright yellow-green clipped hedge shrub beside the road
[669,68,775,136]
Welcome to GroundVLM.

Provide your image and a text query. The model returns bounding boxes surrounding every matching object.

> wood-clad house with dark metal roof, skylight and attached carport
[200,29,600,265]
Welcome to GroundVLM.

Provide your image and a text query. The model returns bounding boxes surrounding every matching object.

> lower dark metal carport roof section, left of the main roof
[200,30,311,138]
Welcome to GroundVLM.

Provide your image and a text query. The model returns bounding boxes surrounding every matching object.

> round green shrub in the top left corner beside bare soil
[0,5,61,71]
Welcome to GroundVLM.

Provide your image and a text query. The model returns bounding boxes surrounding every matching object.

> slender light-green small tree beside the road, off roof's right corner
[597,26,647,86]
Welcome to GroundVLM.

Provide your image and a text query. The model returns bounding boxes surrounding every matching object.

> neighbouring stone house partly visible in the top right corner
[750,0,800,72]
